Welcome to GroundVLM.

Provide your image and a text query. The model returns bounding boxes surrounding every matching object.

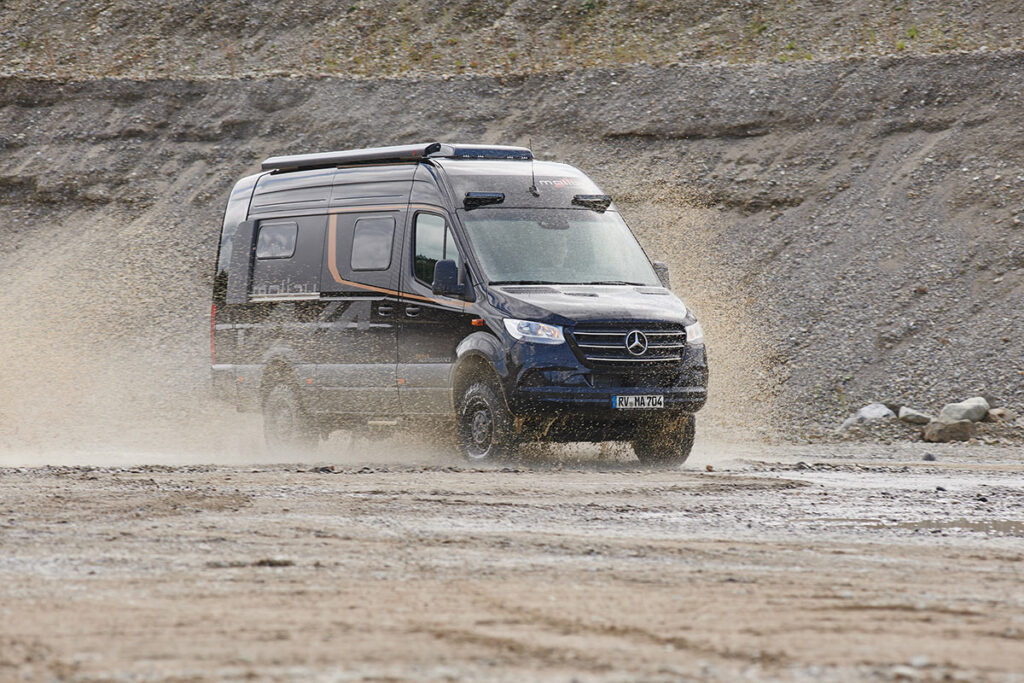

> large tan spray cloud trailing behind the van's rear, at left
[0,200,261,463]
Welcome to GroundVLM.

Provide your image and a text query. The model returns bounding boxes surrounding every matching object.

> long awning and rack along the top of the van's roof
[261,142,534,171]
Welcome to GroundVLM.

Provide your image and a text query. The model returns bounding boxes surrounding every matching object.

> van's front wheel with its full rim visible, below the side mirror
[456,382,514,462]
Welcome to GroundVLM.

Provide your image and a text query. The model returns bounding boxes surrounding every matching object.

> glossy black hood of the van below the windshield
[487,285,687,326]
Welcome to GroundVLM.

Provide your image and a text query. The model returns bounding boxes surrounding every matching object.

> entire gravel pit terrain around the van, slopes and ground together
[0,0,1024,681]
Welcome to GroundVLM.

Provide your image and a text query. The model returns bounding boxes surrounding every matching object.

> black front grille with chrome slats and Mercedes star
[569,323,686,368]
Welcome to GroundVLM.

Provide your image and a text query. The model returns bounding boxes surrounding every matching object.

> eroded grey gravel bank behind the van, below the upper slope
[0,52,1024,452]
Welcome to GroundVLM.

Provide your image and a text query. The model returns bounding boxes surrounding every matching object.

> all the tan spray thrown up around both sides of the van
[0,169,770,471]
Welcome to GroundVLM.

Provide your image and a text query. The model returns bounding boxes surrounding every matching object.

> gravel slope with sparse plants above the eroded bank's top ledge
[0,0,1024,79]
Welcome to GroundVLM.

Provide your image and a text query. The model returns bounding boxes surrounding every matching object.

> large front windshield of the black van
[460,208,659,286]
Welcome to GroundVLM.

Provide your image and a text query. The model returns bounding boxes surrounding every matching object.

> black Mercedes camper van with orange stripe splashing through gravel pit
[210,142,708,463]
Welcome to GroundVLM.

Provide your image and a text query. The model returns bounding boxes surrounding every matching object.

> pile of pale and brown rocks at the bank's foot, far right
[838,396,1017,442]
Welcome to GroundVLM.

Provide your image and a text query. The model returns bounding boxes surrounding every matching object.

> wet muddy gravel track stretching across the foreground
[0,445,1024,681]
